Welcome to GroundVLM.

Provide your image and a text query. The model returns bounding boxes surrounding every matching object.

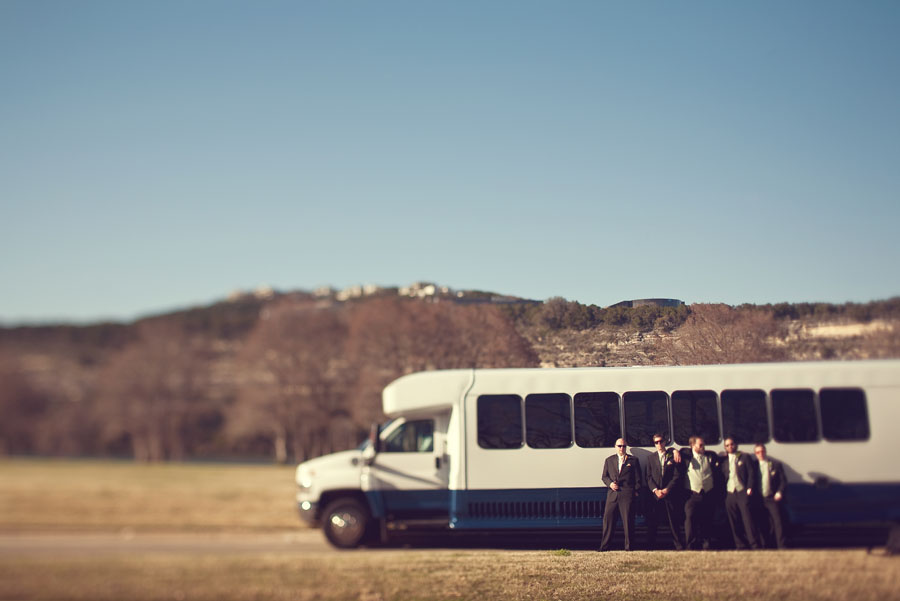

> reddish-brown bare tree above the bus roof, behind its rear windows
[663,304,785,365]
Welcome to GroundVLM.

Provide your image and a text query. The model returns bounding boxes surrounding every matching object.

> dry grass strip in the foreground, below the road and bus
[0,550,900,601]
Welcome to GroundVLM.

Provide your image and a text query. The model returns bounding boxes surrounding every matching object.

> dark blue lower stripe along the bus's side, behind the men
[366,483,900,530]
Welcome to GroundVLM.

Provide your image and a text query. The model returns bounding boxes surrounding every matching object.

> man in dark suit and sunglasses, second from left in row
[647,433,683,551]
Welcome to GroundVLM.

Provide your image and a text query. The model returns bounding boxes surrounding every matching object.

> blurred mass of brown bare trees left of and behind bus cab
[0,298,537,461]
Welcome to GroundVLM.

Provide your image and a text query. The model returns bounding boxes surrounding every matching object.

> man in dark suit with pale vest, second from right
[721,437,759,550]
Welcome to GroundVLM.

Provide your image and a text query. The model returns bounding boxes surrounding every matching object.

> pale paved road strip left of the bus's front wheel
[0,530,336,557]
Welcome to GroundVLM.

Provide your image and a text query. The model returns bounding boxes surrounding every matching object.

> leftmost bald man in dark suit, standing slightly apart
[600,438,641,551]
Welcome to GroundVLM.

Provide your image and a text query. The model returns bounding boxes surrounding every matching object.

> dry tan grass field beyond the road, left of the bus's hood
[0,459,301,532]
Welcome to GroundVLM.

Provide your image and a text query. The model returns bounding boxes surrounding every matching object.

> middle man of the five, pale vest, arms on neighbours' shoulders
[679,436,720,550]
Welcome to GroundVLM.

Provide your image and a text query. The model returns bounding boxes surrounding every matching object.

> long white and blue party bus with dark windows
[296,360,900,547]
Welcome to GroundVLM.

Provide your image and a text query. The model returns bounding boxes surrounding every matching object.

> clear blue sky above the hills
[0,0,900,324]
